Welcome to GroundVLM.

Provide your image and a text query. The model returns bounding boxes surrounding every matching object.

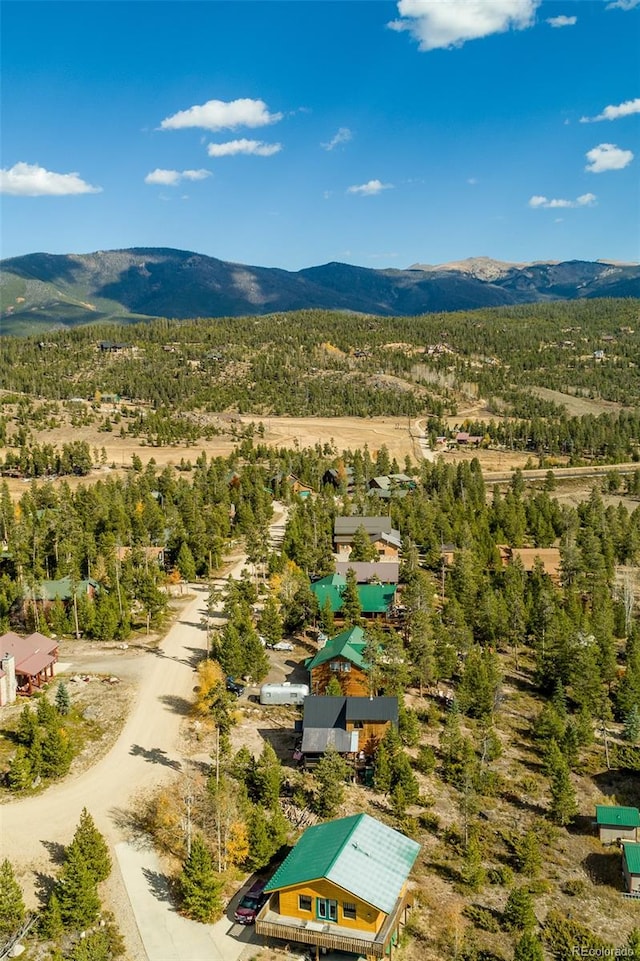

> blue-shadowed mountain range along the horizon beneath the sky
[0,248,640,333]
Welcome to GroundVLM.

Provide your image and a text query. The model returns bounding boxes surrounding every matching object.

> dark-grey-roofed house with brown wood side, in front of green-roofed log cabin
[300,695,398,766]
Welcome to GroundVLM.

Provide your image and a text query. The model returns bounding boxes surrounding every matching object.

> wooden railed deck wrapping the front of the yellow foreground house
[255,893,411,961]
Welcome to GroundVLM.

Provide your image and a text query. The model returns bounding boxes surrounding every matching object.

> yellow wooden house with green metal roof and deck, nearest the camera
[256,814,420,961]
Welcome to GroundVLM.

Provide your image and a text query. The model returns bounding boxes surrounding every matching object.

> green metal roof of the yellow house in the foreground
[265,814,420,914]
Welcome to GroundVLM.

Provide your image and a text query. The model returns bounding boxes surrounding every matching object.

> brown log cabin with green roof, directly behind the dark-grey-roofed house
[305,627,370,697]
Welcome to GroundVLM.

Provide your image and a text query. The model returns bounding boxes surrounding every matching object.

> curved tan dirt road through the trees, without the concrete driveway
[0,560,244,961]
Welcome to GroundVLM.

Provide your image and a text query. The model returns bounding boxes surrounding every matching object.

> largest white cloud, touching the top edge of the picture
[388,0,541,50]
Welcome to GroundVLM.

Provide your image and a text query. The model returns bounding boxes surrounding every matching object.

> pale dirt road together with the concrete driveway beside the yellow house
[0,505,282,961]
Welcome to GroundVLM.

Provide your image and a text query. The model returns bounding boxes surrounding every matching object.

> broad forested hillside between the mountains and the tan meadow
[0,300,640,473]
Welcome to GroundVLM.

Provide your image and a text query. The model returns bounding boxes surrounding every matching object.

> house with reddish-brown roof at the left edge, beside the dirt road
[0,631,59,706]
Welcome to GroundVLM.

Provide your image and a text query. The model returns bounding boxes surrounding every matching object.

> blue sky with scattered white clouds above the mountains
[0,0,640,270]
